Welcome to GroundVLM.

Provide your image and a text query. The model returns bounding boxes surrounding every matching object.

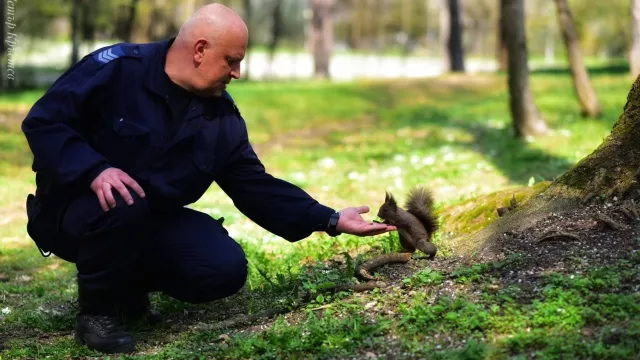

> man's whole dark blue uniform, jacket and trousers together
[22,39,334,310]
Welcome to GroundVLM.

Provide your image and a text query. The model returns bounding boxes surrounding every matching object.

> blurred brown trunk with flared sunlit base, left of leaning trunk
[501,0,547,137]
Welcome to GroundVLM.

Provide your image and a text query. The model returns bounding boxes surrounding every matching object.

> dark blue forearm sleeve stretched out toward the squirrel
[217,121,335,242]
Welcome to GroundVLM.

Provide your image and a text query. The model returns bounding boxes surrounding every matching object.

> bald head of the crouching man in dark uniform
[165,4,249,96]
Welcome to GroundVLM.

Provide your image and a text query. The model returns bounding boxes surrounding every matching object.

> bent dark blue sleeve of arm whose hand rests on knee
[22,56,113,185]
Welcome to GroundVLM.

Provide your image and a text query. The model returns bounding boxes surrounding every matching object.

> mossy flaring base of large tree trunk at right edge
[458,77,640,255]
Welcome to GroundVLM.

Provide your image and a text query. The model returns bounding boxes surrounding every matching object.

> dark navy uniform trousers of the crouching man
[55,189,247,313]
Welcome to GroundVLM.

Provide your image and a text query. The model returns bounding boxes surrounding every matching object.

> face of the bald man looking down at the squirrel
[196,34,246,96]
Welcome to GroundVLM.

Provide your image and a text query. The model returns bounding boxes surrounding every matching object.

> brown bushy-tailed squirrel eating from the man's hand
[378,187,439,259]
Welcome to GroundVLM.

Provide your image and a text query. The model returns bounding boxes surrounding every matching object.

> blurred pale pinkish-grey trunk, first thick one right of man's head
[311,0,334,78]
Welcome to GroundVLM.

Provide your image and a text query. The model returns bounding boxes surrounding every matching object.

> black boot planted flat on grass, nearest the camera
[75,286,135,354]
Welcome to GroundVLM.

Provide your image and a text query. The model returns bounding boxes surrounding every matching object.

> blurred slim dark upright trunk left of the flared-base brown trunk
[440,0,464,72]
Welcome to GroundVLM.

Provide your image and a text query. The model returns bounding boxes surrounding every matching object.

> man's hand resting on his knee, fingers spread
[91,168,145,211]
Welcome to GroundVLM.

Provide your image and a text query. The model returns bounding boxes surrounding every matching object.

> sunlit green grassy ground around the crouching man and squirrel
[0,67,640,359]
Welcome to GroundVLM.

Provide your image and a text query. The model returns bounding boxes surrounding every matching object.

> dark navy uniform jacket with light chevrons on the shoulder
[22,39,334,245]
